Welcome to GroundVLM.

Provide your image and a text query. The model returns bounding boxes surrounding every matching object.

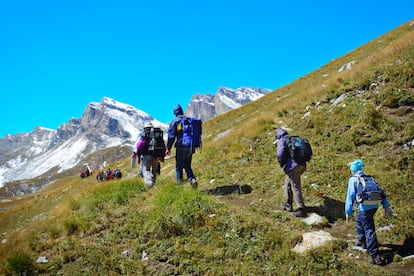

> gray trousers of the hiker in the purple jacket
[285,166,306,208]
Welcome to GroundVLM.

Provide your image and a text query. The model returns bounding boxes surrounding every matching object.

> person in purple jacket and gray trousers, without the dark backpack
[273,128,307,217]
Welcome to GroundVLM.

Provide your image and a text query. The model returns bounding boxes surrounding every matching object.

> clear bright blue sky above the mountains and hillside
[0,0,414,138]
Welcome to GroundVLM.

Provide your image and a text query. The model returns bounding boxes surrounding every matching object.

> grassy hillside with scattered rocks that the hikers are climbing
[0,19,414,275]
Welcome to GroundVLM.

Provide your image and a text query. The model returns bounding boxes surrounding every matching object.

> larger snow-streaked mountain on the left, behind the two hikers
[0,97,167,193]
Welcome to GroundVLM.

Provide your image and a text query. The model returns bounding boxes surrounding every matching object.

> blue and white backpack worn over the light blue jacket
[354,174,386,205]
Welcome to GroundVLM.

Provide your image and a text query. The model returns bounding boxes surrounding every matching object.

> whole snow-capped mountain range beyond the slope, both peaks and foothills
[0,87,272,195]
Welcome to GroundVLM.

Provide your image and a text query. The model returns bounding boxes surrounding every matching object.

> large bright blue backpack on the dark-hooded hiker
[179,116,202,149]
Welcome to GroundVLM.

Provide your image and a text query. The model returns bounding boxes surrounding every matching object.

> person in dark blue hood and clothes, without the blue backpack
[166,104,198,188]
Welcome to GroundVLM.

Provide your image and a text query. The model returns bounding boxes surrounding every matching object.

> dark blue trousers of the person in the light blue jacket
[356,208,379,256]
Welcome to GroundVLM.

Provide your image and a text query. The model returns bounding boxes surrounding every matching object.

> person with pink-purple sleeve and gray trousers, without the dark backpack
[135,122,165,188]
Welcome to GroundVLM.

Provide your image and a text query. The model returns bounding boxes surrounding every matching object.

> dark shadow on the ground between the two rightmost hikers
[307,197,345,223]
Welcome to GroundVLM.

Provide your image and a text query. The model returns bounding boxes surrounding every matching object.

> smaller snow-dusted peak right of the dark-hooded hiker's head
[185,87,272,121]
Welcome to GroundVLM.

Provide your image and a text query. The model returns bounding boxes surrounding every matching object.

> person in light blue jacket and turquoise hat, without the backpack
[345,159,394,265]
